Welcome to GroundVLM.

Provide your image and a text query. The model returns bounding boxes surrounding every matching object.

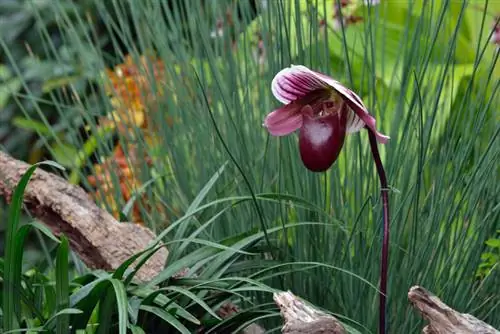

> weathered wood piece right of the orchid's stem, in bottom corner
[408,286,500,334]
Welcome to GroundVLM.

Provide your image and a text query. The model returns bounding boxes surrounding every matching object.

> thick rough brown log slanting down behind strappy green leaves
[0,152,168,281]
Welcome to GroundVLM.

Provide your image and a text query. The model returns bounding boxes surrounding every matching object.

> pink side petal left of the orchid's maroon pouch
[263,104,302,136]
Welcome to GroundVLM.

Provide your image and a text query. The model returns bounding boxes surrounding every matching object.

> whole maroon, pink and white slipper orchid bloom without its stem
[264,65,389,172]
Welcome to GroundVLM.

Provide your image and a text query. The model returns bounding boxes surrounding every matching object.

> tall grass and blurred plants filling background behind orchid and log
[0,0,500,332]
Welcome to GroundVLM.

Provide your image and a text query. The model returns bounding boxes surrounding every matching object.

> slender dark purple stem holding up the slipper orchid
[368,129,389,334]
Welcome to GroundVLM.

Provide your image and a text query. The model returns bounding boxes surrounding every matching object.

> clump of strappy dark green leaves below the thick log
[1,158,300,333]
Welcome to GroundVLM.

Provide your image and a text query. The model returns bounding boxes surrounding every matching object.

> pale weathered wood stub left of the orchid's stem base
[273,291,347,334]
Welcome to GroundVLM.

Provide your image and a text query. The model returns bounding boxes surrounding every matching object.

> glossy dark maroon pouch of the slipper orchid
[299,113,347,172]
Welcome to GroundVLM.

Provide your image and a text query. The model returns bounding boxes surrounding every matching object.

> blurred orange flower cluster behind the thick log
[87,55,173,224]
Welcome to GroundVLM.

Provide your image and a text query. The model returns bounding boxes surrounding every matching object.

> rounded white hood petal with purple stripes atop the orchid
[271,65,330,104]
